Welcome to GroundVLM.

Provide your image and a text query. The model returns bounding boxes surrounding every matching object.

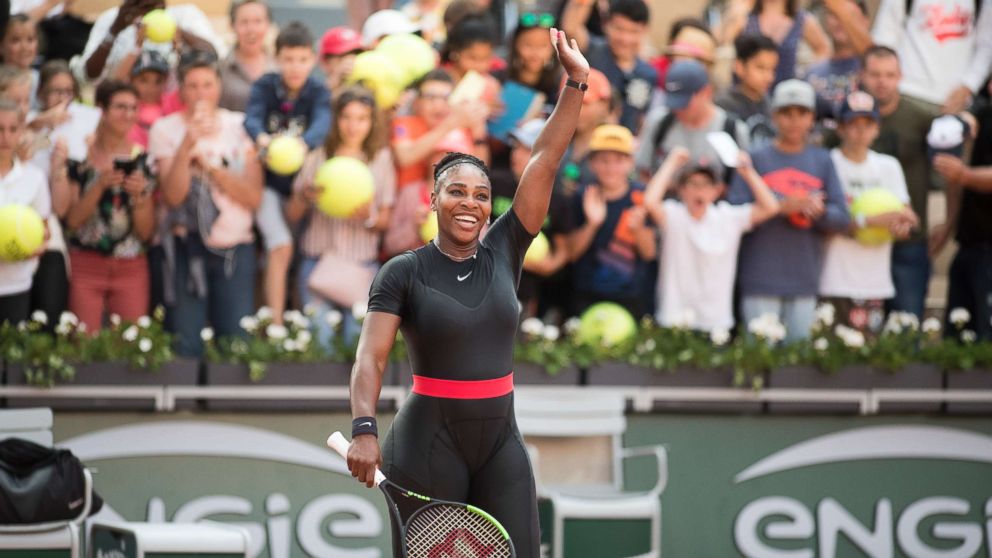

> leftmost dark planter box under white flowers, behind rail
[7,358,200,410]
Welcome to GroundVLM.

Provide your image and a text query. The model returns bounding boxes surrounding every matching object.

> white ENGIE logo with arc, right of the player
[734,426,992,558]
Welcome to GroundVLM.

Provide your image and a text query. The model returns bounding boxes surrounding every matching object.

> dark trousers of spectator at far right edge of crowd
[945,246,992,341]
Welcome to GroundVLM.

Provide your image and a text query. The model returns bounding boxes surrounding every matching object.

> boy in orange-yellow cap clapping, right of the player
[569,124,657,318]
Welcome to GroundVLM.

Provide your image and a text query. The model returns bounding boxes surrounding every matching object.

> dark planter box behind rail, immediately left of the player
[203,362,360,412]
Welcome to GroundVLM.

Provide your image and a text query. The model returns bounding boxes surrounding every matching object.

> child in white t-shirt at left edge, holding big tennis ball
[0,99,49,324]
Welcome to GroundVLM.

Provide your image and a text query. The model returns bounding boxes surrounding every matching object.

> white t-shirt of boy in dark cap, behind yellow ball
[820,148,909,300]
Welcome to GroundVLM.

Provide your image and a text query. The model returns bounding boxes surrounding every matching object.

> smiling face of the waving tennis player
[431,163,492,245]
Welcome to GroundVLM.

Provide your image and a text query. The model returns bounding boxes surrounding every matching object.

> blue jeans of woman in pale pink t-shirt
[166,237,255,357]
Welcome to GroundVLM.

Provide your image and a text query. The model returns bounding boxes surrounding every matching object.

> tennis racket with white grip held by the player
[327,432,516,558]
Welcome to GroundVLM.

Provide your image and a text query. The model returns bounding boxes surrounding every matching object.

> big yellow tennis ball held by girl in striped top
[313,157,375,219]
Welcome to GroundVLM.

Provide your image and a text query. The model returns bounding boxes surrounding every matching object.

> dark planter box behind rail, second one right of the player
[587,362,763,413]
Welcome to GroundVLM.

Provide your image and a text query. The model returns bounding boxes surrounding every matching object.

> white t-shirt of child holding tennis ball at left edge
[0,159,52,296]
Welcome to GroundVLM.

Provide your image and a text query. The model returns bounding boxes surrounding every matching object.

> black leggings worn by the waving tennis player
[382,393,541,558]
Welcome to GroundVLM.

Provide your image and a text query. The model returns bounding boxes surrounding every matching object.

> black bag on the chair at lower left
[0,438,103,525]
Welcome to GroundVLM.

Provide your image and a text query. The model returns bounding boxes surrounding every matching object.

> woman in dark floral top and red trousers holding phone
[58,80,155,331]
